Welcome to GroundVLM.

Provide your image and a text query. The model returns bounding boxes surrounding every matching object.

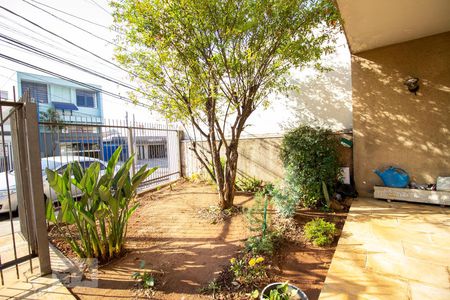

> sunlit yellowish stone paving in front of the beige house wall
[319,198,450,300]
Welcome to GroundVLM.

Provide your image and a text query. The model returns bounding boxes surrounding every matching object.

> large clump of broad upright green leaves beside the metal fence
[46,147,157,261]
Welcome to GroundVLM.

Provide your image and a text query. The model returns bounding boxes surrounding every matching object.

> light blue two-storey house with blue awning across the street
[17,72,103,158]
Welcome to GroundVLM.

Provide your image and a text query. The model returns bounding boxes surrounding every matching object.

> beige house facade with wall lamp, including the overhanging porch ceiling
[336,0,450,197]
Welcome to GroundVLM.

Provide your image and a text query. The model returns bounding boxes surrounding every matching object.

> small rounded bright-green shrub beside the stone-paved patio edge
[304,218,336,247]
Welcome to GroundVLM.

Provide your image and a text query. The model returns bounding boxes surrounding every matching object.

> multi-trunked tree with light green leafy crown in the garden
[112,0,339,209]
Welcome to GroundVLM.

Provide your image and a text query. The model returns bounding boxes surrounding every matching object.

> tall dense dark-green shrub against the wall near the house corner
[281,126,340,207]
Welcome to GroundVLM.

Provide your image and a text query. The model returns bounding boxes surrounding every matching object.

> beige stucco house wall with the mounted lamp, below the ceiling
[352,32,450,196]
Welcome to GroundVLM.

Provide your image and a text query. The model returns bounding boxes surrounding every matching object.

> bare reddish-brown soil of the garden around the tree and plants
[51,182,346,299]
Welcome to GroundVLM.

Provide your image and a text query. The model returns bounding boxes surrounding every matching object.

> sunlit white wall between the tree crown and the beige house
[245,34,352,135]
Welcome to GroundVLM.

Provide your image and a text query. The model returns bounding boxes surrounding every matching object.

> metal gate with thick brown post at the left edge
[0,93,51,285]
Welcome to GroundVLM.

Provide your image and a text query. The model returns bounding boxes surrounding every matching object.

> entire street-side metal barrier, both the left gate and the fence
[0,93,182,284]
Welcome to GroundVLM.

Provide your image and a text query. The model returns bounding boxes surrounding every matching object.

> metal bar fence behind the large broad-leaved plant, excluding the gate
[39,116,181,191]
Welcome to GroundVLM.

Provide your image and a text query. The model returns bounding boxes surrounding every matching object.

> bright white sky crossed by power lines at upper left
[0,0,164,123]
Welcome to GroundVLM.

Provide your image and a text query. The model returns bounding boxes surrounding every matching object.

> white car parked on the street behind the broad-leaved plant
[0,156,108,213]
